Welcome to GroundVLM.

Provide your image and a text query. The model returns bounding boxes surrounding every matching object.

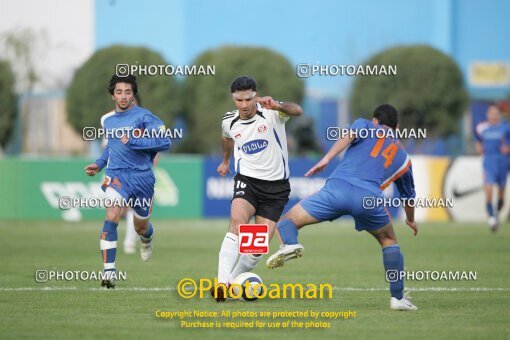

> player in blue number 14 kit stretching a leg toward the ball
[266,104,418,310]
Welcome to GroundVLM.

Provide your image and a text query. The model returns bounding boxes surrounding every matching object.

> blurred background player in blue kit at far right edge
[475,104,510,232]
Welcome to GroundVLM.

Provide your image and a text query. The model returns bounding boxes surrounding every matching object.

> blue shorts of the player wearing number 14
[300,178,391,231]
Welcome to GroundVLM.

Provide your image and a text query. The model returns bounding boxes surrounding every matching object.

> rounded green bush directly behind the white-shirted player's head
[178,46,304,153]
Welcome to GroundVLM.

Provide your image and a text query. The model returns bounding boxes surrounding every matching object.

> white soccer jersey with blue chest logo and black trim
[222,105,289,181]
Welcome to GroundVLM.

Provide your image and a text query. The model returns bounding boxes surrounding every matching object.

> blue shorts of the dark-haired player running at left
[101,169,156,218]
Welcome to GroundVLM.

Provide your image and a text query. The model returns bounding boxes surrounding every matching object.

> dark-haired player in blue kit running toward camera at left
[85,75,171,288]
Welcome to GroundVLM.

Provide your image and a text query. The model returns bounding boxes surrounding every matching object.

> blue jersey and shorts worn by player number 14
[301,119,416,231]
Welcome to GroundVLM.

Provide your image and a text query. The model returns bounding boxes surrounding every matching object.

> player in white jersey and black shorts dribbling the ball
[211,76,303,302]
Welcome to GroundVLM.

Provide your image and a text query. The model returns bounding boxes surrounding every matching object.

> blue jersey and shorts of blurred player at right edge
[475,122,509,186]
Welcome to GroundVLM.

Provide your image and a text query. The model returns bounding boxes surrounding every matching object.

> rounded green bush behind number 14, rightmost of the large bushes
[350,45,469,137]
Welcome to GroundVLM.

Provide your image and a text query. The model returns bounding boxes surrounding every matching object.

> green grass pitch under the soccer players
[0,220,510,339]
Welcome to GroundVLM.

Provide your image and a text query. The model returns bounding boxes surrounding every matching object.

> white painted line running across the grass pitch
[0,286,510,292]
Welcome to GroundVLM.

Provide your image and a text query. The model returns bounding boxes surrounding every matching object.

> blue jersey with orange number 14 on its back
[329,118,414,197]
